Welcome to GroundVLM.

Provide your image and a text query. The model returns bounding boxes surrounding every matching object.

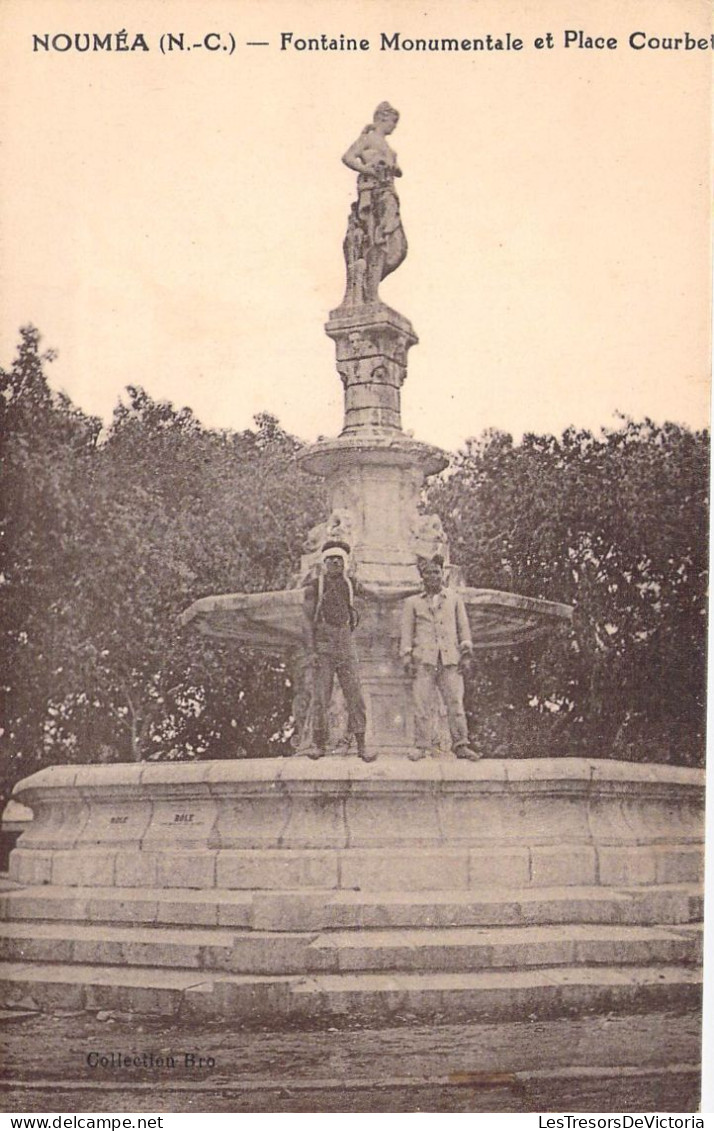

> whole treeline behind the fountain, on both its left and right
[0,327,708,805]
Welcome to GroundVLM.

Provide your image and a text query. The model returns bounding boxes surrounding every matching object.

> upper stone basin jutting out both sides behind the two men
[181,586,573,651]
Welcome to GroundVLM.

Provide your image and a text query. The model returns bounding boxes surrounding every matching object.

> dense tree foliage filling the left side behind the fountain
[0,327,324,805]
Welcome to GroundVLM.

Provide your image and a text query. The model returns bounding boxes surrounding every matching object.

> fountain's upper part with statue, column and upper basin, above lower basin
[183,103,571,756]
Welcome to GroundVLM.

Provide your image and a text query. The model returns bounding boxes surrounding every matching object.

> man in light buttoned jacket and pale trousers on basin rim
[399,554,481,762]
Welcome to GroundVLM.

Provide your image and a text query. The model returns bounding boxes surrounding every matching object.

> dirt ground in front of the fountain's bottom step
[1,1012,700,1114]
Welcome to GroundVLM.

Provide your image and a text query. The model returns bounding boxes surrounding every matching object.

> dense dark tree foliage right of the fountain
[430,420,708,765]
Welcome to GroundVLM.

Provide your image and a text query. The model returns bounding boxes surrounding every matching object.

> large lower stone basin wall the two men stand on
[10,757,704,895]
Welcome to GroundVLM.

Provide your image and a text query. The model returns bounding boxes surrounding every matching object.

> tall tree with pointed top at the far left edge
[0,326,101,796]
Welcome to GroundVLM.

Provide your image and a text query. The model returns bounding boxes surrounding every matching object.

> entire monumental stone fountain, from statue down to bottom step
[0,104,704,1020]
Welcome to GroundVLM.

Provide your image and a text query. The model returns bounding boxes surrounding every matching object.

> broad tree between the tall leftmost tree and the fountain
[66,388,319,758]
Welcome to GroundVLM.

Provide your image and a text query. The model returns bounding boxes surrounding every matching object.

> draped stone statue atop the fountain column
[342,102,407,307]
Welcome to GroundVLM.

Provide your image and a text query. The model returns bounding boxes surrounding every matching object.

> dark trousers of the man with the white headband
[312,624,367,745]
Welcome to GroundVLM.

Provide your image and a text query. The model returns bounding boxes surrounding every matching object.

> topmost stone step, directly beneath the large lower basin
[0,884,702,931]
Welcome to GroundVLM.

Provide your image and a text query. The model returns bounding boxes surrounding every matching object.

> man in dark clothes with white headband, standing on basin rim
[303,541,377,762]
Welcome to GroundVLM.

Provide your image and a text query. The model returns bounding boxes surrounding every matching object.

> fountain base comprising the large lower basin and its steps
[2,758,704,1021]
